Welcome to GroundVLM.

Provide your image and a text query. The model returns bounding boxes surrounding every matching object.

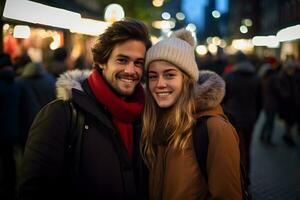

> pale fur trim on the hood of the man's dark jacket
[56,69,91,100]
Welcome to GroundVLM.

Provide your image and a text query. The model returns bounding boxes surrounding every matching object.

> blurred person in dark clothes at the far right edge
[278,59,300,147]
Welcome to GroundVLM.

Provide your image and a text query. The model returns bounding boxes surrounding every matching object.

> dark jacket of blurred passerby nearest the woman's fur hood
[223,61,261,129]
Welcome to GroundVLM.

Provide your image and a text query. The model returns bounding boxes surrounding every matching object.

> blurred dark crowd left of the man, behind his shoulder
[0,48,91,199]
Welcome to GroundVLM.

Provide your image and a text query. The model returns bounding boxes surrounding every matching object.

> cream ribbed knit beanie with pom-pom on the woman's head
[145,29,199,81]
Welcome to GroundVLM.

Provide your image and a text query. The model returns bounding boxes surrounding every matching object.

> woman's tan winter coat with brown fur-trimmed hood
[149,72,242,200]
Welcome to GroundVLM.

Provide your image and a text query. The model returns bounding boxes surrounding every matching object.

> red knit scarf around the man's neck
[88,69,145,158]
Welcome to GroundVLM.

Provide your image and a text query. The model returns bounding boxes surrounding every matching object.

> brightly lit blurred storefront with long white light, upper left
[0,0,108,69]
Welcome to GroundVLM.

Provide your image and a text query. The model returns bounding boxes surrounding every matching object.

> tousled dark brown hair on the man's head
[92,19,151,64]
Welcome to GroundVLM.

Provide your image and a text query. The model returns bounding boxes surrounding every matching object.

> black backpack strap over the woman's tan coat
[193,116,209,182]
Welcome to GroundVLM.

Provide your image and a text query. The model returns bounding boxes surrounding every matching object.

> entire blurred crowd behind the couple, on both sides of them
[0,48,300,199]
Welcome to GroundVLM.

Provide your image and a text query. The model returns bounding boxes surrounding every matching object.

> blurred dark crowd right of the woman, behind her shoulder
[197,50,300,171]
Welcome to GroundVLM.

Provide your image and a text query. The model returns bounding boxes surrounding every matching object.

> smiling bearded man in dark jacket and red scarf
[19,19,151,199]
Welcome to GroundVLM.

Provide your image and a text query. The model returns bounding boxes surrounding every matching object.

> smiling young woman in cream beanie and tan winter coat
[141,29,242,200]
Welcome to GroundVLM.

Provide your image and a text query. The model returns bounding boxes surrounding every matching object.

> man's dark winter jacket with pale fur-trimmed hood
[19,71,147,200]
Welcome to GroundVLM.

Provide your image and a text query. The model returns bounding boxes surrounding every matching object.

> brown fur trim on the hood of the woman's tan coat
[195,70,225,111]
